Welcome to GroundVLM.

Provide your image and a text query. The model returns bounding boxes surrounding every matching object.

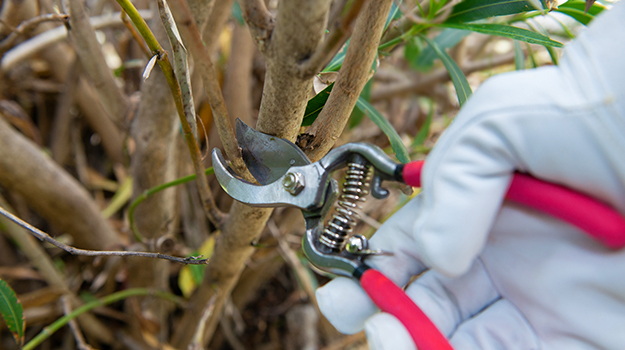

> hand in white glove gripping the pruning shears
[317,3,625,350]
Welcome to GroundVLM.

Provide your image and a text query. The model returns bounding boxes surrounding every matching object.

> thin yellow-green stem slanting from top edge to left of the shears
[117,0,225,227]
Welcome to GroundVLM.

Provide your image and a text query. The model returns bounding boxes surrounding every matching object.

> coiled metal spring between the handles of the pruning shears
[319,161,371,251]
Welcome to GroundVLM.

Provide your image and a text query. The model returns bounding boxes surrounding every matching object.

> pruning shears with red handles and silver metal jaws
[212,120,625,350]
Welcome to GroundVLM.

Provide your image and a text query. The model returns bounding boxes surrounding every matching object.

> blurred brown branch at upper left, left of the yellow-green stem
[69,0,129,123]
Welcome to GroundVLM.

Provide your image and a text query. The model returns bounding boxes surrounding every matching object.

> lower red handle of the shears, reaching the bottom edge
[360,269,453,350]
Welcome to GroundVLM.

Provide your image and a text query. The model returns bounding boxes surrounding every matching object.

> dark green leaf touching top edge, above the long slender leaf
[445,0,535,23]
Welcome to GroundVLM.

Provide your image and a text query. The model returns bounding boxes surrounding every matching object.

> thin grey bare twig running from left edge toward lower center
[0,207,208,265]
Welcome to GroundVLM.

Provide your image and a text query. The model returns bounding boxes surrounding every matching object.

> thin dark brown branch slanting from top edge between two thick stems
[300,0,365,77]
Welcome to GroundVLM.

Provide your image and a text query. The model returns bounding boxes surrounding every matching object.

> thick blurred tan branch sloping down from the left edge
[0,118,119,249]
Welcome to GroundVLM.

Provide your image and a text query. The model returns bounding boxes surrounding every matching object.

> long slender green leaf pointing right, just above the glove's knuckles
[442,23,564,47]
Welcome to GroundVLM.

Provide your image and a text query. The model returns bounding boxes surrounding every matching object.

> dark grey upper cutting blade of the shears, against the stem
[236,119,310,185]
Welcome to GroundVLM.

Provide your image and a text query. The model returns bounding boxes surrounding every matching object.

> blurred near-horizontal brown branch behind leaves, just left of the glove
[371,52,514,102]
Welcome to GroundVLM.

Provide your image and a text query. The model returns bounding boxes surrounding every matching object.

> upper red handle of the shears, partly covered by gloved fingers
[402,161,625,249]
